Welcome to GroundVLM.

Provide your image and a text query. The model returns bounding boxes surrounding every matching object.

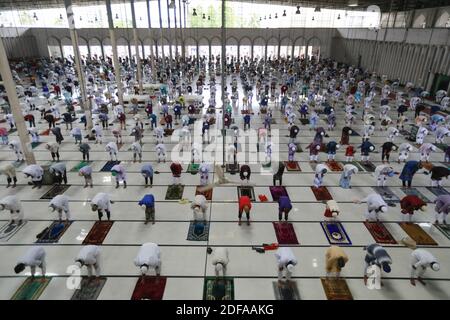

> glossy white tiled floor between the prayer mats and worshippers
[0,72,450,300]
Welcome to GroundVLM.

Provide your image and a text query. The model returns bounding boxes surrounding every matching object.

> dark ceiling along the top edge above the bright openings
[0,0,450,12]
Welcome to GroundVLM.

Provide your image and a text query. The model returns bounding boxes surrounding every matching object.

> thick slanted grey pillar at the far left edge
[0,38,36,164]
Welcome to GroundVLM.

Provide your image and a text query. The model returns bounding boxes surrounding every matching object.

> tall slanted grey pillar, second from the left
[64,0,93,138]
